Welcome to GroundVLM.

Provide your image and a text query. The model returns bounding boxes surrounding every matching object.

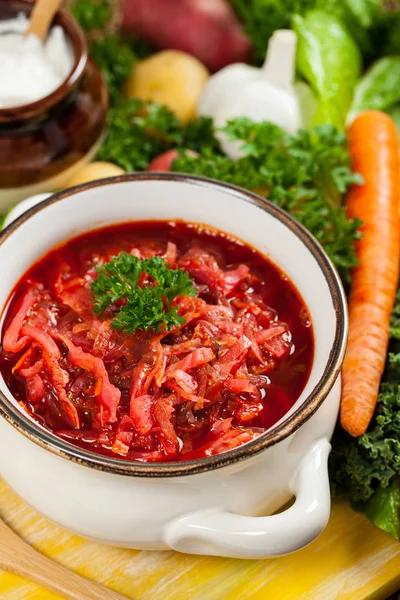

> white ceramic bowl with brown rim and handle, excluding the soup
[0,173,347,558]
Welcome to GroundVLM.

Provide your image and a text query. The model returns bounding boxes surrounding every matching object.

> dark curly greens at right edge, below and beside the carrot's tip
[330,289,400,539]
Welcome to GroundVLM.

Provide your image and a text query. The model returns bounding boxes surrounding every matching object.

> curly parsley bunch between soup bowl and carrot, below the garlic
[173,118,360,283]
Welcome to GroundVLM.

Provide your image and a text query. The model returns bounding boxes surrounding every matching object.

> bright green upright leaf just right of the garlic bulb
[293,10,361,128]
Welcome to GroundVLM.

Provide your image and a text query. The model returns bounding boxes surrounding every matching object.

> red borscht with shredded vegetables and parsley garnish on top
[0,221,314,462]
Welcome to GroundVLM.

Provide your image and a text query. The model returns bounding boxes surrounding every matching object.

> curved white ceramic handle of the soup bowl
[164,438,331,558]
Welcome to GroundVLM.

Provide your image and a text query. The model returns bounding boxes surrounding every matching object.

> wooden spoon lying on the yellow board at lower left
[0,519,131,600]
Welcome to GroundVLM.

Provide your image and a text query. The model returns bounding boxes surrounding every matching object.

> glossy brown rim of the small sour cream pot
[0,0,88,123]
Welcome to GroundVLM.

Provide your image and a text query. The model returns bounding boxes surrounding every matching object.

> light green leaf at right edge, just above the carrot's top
[350,56,400,117]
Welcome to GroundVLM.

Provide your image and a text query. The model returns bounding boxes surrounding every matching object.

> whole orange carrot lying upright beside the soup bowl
[340,110,400,437]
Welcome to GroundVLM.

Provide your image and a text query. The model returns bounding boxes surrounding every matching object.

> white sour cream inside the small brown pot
[0,14,74,109]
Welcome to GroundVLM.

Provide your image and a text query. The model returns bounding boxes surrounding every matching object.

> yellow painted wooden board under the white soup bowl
[0,480,400,600]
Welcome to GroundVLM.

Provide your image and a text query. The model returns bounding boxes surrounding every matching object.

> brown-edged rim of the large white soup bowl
[0,172,348,477]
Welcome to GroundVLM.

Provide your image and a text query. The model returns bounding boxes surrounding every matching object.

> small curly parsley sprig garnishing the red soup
[91,252,197,334]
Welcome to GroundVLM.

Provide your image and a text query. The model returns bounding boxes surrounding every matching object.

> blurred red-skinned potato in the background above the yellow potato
[123,0,251,71]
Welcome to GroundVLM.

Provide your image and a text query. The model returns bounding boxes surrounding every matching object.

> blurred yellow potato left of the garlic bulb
[126,50,209,122]
